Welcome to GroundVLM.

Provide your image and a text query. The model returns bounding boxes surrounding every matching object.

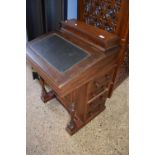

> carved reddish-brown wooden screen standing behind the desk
[78,0,129,96]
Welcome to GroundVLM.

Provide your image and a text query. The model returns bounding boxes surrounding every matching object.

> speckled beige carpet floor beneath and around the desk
[26,65,129,155]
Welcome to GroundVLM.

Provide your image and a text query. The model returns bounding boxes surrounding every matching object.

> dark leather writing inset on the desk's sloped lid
[31,35,89,72]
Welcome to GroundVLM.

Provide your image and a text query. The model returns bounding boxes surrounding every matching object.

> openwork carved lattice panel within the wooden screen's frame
[83,0,122,32]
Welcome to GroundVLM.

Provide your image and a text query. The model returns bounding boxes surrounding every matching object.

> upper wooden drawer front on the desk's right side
[88,70,113,99]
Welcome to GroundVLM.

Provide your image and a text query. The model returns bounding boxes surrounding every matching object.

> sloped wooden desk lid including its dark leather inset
[26,31,116,93]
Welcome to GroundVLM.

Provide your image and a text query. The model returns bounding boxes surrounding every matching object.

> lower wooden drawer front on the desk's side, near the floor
[87,91,108,117]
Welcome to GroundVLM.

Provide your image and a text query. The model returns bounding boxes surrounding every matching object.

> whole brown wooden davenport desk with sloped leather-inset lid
[26,21,119,135]
